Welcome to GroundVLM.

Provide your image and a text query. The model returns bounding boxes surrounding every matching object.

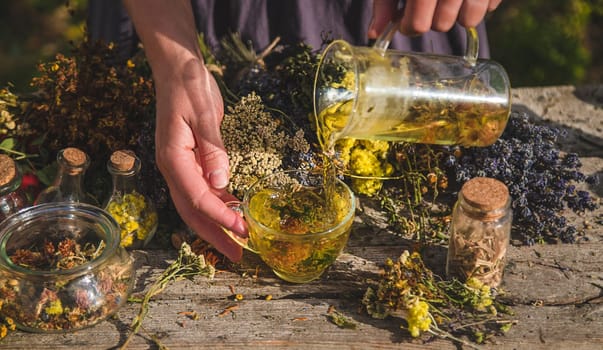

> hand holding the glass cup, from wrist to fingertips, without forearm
[155,60,245,261]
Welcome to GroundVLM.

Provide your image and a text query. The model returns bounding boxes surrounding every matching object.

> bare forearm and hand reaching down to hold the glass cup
[124,0,247,261]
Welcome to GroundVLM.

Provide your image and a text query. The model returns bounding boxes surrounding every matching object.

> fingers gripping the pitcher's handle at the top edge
[368,0,502,38]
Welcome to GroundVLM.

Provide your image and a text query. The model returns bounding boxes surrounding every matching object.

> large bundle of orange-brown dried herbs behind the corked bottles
[16,40,168,216]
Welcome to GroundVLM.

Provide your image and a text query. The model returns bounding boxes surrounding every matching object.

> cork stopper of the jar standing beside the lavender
[461,177,509,211]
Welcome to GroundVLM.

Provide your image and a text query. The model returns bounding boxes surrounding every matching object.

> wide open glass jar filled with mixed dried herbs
[0,202,135,332]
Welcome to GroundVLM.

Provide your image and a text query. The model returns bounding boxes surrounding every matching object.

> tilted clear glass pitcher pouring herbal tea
[314,23,511,153]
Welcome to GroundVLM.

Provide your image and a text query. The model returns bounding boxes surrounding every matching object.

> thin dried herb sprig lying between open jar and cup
[120,243,215,349]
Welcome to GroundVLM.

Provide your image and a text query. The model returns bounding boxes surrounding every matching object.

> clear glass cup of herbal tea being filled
[224,170,356,283]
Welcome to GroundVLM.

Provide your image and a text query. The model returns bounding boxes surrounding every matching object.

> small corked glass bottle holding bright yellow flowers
[104,150,158,249]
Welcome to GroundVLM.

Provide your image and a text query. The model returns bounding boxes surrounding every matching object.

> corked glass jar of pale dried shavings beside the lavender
[446,177,512,287]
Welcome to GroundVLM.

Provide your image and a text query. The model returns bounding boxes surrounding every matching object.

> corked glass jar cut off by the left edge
[0,154,28,221]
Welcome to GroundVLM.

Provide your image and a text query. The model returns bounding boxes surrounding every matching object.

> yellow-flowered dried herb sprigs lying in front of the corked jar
[362,251,515,345]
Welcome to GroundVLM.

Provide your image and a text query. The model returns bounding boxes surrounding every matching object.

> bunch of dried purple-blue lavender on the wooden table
[445,112,598,245]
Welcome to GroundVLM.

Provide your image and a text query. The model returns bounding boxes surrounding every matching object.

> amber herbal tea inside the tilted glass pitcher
[318,95,508,150]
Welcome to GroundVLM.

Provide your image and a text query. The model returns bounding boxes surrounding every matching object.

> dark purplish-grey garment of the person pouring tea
[88,0,490,58]
